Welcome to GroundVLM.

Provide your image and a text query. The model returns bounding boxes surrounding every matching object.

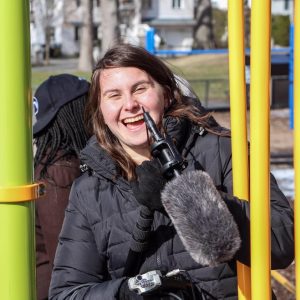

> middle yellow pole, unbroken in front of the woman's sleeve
[250,0,271,300]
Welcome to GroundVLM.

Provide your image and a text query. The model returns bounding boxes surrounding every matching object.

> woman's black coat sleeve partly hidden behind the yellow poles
[220,138,294,269]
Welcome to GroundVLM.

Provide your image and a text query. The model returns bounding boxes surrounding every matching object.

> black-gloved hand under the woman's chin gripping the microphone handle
[131,159,166,210]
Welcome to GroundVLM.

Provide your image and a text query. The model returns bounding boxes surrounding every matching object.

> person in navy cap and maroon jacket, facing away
[33,74,90,300]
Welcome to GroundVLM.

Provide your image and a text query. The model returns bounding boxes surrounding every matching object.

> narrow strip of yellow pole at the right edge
[294,0,300,299]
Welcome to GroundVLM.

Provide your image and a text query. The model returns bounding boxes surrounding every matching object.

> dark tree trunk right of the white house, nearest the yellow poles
[193,0,216,49]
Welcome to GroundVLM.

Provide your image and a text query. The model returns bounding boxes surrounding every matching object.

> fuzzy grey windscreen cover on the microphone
[161,171,241,266]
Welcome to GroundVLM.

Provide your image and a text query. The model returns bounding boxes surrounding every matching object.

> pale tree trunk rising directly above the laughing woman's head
[101,0,120,55]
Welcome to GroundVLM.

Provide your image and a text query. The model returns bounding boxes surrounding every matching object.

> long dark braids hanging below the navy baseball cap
[34,95,89,179]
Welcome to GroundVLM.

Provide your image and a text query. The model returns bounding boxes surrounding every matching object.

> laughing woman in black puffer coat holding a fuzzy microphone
[49,44,294,300]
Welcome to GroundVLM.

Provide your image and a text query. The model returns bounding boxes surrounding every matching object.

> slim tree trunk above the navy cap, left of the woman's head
[78,0,94,72]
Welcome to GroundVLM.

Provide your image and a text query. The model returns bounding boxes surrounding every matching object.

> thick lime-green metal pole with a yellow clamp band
[0,0,36,300]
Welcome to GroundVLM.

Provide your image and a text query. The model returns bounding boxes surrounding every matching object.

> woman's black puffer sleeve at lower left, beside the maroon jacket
[49,185,124,300]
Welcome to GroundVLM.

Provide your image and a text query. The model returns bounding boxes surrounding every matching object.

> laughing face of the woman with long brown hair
[100,67,168,156]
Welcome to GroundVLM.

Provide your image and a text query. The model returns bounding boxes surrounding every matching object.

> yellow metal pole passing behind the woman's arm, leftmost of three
[228,0,251,300]
